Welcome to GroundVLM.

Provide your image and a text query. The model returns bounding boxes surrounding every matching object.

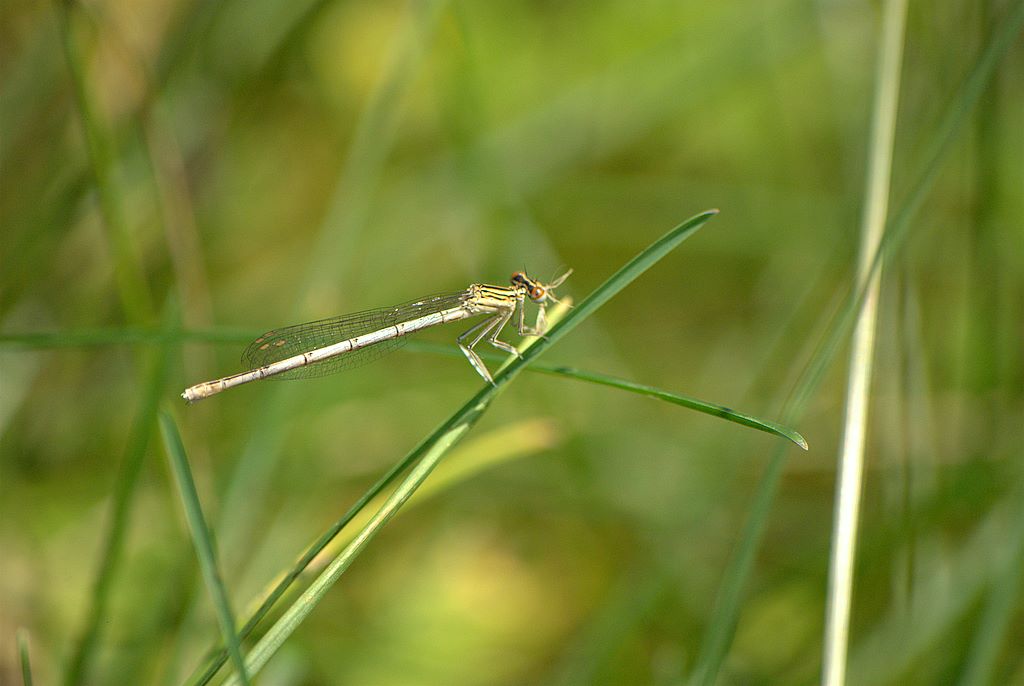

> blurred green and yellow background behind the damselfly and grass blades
[0,0,1024,685]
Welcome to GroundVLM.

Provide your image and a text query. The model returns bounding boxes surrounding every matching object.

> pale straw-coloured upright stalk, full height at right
[821,0,906,686]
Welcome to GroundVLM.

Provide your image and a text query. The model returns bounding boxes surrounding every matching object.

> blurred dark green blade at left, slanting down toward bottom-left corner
[63,302,180,686]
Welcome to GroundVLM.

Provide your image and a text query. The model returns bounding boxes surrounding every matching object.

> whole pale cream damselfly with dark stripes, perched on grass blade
[181,269,572,402]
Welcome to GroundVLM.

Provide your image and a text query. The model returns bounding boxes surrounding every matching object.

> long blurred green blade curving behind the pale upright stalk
[690,2,1024,686]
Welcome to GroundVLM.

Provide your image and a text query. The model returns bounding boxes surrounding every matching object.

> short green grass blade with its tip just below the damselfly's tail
[160,412,249,686]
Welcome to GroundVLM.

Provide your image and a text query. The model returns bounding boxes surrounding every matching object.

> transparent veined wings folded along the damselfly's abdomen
[242,291,469,379]
